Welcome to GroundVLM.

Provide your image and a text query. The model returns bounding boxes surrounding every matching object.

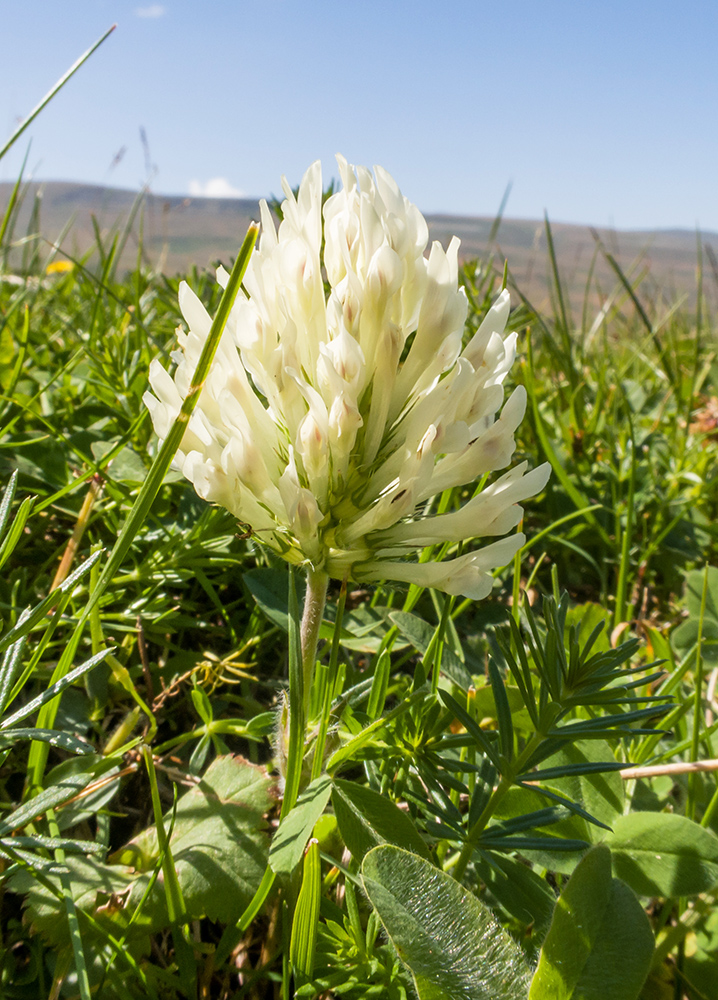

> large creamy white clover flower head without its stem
[144,157,550,599]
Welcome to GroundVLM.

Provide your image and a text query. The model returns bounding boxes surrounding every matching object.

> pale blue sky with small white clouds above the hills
[0,0,718,231]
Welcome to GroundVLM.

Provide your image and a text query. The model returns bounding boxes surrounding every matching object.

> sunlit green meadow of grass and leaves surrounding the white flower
[0,56,718,1000]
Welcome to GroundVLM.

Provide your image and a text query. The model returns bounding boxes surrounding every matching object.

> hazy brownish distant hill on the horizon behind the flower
[0,181,718,309]
